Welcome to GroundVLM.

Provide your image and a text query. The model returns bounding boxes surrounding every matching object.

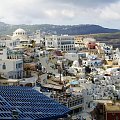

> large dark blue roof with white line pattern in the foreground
[0,86,70,120]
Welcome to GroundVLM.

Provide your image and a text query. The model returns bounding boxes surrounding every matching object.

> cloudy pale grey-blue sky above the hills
[0,0,120,29]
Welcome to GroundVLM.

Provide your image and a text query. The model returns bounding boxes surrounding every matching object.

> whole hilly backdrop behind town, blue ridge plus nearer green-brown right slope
[0,22,120,48]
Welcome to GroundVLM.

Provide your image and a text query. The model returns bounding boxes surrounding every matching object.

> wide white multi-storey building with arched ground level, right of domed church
[45,35,75,51]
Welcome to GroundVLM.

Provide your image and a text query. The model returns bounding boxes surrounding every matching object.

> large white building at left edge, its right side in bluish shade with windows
[0,46,23,79]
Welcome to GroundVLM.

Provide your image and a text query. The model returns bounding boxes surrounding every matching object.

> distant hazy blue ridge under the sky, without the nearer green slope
[0,22,120,35]
